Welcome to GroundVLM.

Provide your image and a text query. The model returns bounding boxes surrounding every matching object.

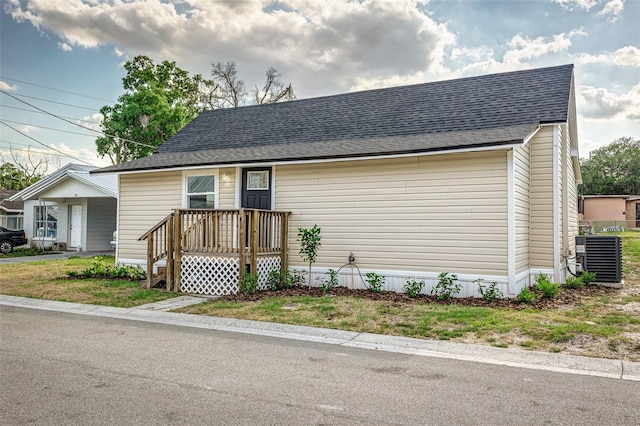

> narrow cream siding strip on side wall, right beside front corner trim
[513,144,530,273]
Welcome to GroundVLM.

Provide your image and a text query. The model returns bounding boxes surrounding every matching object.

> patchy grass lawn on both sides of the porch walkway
[0,232,640,361]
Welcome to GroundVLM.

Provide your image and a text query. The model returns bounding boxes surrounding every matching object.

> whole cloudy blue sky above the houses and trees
[0,0,640,171]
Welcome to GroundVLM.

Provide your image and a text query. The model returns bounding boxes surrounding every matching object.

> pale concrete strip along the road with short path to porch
[0,295,640,381]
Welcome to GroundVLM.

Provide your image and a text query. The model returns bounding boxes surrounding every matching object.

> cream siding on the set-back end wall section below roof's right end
[529,126,554,269]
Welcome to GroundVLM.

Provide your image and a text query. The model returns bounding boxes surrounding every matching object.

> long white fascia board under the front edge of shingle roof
[112,142,522,175]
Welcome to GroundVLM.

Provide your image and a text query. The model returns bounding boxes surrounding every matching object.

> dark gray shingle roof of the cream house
[92,65,573,172]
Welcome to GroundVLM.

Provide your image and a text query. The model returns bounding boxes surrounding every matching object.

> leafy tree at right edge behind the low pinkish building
[579,137,640,195]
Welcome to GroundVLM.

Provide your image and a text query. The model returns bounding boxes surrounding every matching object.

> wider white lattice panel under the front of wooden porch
[180,256,240,296]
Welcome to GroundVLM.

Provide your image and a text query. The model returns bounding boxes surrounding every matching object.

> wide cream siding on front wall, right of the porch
[276,151,507,276]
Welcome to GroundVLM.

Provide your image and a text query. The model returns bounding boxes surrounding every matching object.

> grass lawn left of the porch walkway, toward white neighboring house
[0,256,177,308]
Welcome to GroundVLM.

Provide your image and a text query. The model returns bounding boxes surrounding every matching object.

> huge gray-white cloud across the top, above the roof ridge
[3,0,455,96]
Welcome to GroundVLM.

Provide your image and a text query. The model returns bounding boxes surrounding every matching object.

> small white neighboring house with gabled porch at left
[9,164,118,251]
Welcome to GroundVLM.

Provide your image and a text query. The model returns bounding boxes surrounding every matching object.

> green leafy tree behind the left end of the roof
[96,56,214,164]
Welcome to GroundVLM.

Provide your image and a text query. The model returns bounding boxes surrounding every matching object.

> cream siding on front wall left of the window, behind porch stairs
[118,171,182,261]
